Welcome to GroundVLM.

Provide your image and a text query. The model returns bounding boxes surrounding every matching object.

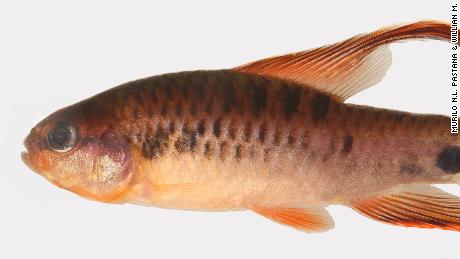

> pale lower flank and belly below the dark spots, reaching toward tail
[128,132,446,211]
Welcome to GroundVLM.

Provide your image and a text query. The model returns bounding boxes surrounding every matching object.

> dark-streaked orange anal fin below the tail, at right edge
[351,186,460,231]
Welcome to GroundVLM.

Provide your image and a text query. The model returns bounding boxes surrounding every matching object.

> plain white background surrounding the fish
[0,0,460,258]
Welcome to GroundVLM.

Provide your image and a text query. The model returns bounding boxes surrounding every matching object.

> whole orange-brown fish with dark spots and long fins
[21,20,460,233]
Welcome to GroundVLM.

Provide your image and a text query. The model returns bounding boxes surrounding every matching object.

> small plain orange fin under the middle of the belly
[251,207,334,232]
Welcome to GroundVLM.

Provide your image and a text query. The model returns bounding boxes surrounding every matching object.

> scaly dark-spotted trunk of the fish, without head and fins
[75,70,455,210]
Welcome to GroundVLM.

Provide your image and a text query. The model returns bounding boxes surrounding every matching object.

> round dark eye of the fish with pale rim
[47,122,78,152]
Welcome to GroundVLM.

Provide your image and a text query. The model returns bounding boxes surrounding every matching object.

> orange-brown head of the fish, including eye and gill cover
[22,103,133,202]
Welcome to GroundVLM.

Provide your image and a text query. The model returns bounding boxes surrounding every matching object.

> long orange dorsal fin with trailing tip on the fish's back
[234,21,450,101]
